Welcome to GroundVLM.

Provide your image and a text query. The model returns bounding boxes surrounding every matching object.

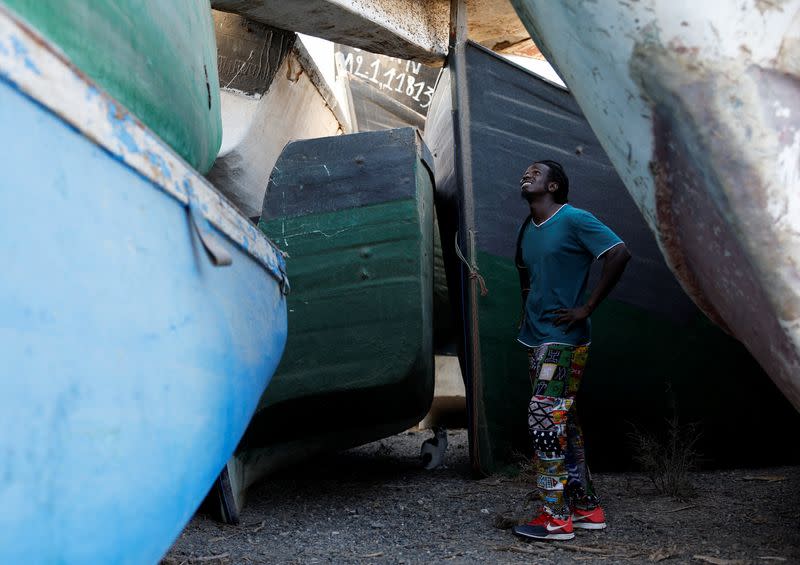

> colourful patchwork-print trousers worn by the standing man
[528,343,598,519]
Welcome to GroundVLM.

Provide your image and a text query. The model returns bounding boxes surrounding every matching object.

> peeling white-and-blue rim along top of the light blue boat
[0,7,285,288]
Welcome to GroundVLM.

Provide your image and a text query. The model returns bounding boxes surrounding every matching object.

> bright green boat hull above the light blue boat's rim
[0,0,222,173]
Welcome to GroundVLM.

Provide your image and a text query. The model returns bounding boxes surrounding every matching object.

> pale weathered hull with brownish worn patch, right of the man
[512,0,800,409]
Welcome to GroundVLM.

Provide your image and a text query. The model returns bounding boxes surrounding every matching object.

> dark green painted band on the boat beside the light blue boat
[261,198,433,415]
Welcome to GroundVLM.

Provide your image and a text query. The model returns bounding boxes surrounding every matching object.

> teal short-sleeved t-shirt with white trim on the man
[518,204,622,347]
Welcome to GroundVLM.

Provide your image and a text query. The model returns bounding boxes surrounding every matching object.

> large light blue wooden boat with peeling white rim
[0,8,286,563]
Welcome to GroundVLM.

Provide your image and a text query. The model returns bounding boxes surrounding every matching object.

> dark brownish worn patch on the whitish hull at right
[631,41,800,407]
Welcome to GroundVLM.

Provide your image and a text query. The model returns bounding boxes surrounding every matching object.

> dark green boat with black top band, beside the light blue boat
[209,128,434,521]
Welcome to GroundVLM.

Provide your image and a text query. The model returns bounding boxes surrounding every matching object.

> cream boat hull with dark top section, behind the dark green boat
[207,11,350,221]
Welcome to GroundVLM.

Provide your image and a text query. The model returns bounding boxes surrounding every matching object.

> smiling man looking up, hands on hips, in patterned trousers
[513,161,631,540]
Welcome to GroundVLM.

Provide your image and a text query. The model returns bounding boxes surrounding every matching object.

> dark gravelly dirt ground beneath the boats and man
[162,430,800,565]
